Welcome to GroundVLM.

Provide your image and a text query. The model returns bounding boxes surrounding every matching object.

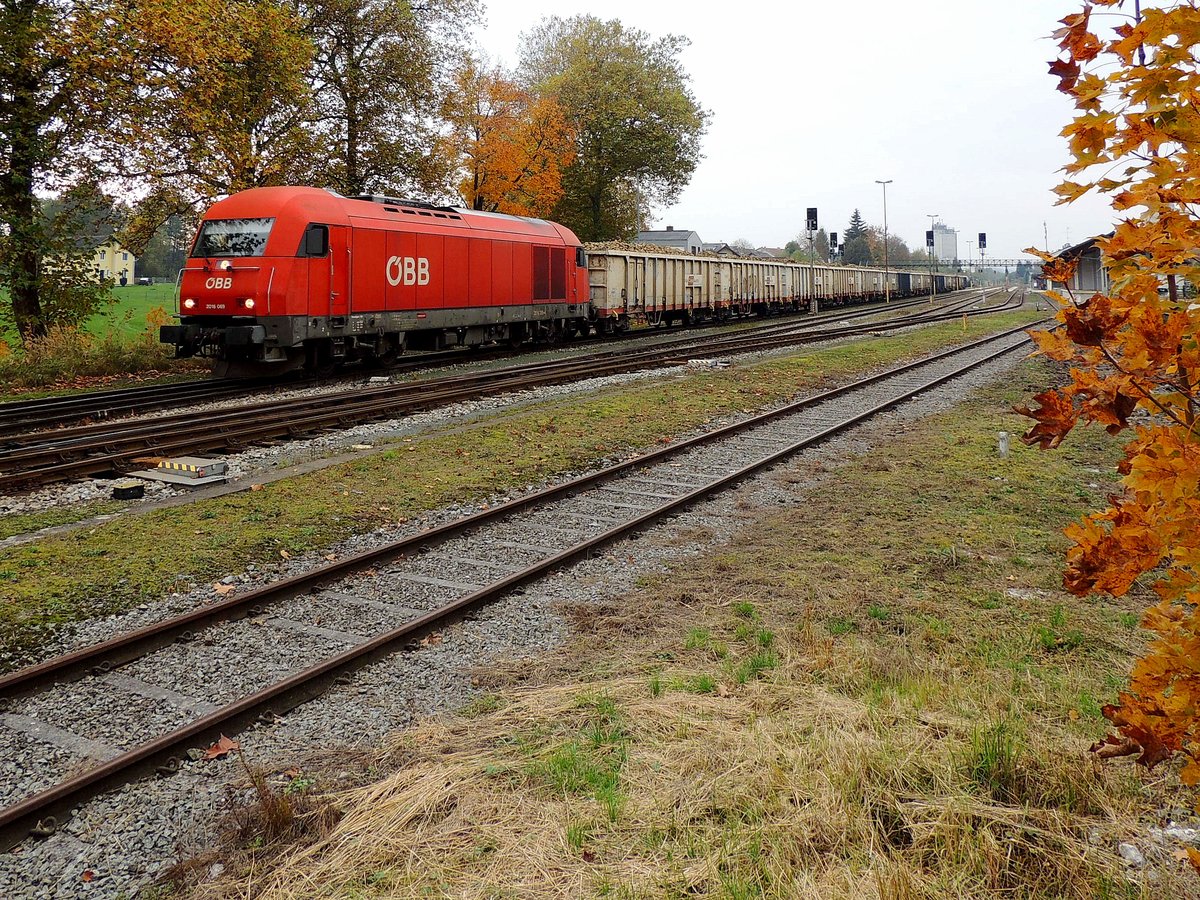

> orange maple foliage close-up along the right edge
[1021,0,1200,785]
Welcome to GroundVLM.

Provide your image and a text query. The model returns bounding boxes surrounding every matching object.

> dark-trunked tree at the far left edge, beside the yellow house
[0,0,137,341]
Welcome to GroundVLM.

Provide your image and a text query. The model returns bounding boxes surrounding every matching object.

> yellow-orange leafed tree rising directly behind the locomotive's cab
[119,0,318,232]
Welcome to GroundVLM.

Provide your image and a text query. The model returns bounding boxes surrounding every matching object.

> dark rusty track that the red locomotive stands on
[0,295,988,444]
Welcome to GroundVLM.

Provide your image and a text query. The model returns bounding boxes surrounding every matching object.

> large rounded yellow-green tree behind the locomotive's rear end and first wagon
[520,16,709,240]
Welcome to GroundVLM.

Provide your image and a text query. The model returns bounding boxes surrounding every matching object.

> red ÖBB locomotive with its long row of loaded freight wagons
[160,187,967,374]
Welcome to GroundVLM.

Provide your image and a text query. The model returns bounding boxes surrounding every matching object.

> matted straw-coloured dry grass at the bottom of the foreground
[196,672,1152,899]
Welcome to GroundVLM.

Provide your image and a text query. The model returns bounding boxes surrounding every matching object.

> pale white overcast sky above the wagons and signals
[468,0,1111,264]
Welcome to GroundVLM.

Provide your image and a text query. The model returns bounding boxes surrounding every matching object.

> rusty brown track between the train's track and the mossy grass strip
[0,293,1024,491]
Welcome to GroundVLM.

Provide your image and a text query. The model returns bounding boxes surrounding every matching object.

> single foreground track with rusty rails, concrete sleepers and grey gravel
[0,314,1028,850]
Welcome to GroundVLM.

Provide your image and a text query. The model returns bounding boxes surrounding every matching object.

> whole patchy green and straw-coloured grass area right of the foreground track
[179,362,1200,900]
